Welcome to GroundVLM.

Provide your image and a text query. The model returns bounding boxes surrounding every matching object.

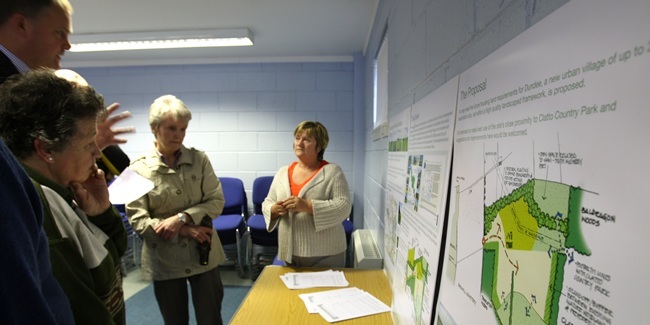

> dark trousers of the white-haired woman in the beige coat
[153,266,223,325]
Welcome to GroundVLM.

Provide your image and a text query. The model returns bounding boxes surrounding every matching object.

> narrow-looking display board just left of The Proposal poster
[384,77,458,324]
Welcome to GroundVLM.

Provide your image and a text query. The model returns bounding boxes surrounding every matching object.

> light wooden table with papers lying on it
[226,265,393,325]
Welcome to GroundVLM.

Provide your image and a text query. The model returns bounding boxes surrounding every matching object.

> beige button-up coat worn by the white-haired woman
[126,147,225,281]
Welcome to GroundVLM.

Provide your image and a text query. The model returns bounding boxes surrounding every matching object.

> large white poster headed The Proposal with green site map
[437,0,650,324]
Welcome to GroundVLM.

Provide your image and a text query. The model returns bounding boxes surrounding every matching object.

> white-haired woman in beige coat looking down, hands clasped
[126,95,225,325]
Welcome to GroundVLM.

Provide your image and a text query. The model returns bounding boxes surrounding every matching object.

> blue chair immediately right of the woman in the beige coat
[212,177,248,278]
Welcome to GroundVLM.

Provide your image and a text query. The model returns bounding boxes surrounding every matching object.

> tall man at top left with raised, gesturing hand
[0,0,134,172]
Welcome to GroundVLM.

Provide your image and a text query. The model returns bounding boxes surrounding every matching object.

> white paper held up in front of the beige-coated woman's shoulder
[108,168,153,204]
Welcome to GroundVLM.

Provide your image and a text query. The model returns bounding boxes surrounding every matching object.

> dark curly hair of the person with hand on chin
[0,69,105,159]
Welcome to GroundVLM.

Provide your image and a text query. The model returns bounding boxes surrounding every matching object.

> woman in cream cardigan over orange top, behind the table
[262,121,351,267]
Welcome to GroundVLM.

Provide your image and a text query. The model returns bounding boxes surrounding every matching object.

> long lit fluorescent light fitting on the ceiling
[70,28,253,52]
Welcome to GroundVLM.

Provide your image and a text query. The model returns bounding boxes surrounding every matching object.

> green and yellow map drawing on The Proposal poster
[481,179,591,324]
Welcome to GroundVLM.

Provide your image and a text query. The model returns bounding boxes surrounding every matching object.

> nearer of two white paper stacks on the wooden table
[298,287,390,323]
